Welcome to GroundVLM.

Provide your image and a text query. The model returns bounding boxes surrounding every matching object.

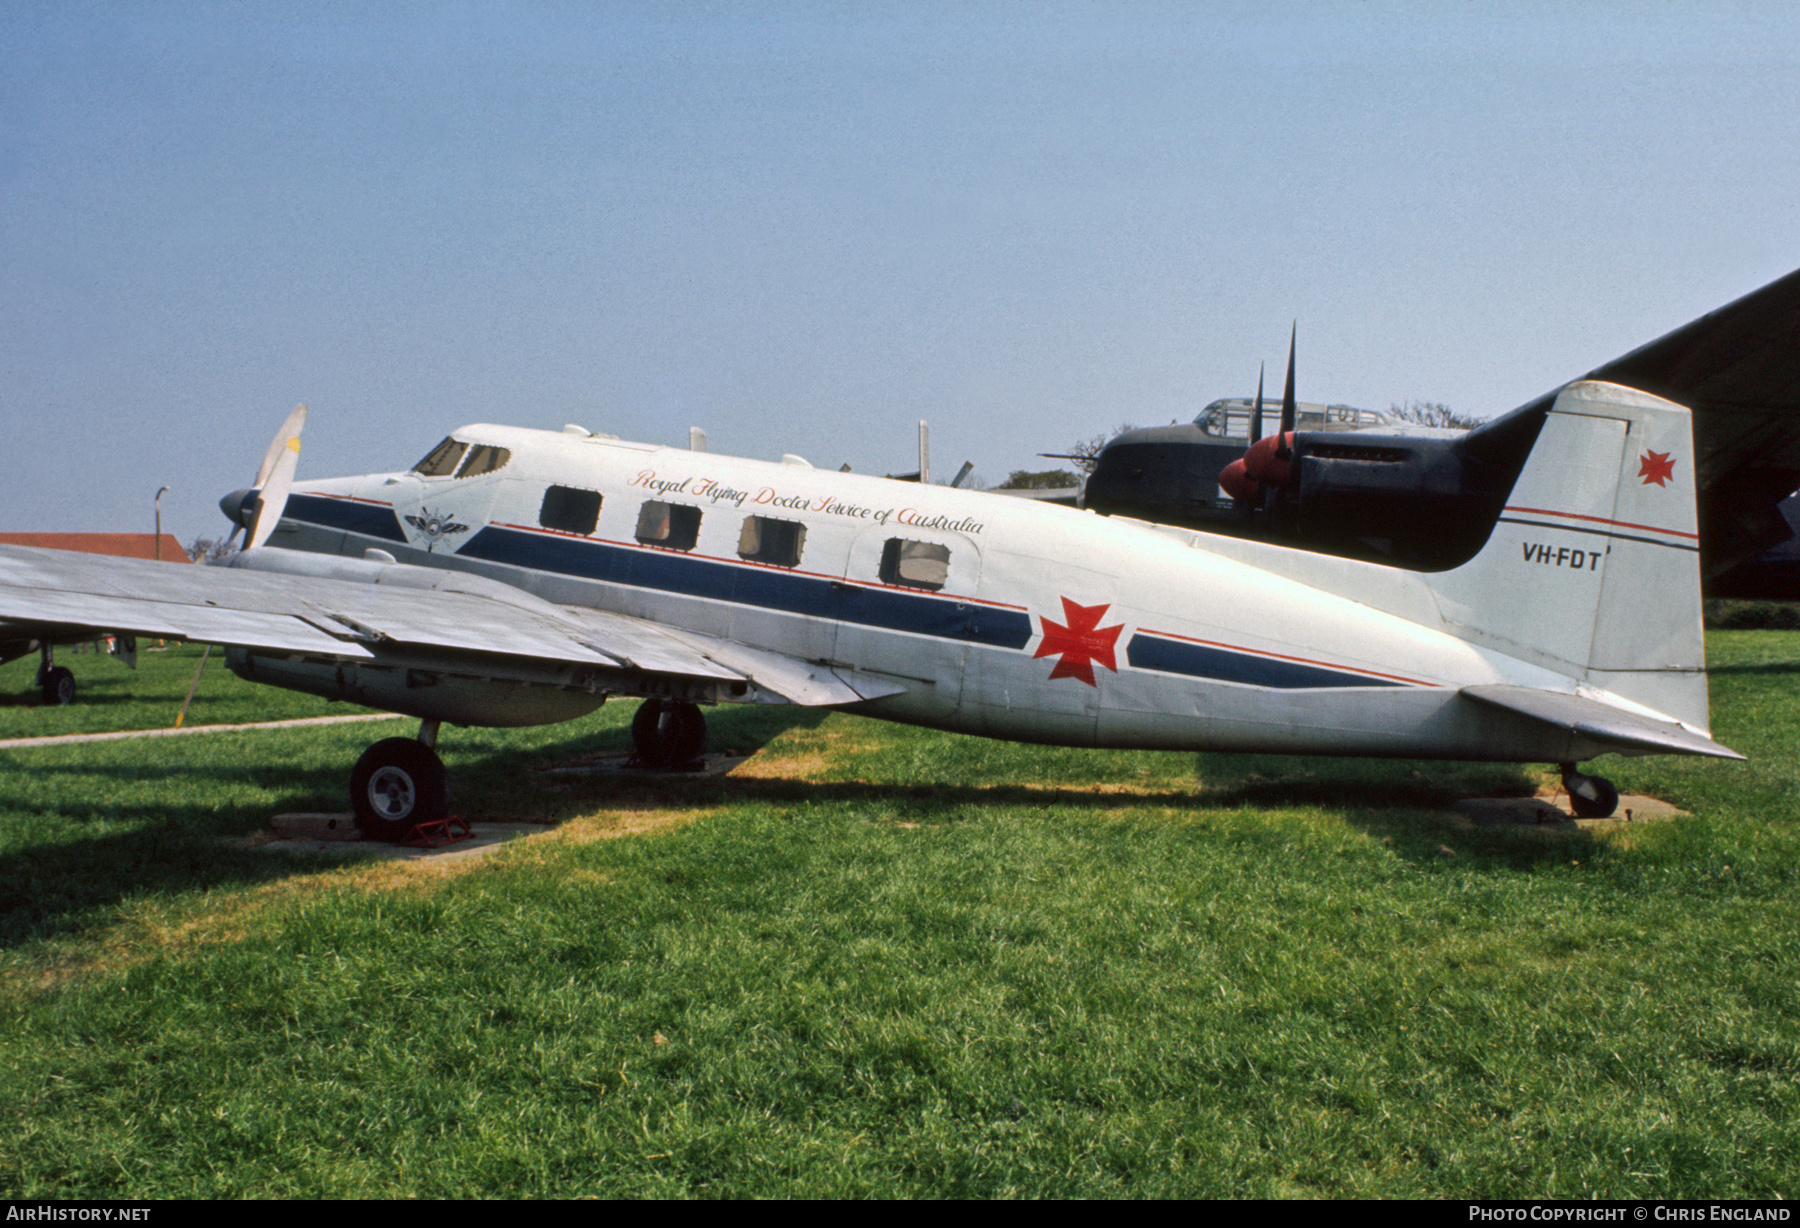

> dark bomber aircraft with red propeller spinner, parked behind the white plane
[1082,262,1800,586]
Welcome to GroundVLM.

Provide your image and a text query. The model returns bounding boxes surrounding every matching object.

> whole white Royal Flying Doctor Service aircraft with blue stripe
[0,382,1741,839]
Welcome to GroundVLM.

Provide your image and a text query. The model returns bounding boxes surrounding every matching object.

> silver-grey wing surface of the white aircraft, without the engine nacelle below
[0,546,904,706]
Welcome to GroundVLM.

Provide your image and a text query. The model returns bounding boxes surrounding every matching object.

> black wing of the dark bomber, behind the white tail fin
[1523,270,1800,576]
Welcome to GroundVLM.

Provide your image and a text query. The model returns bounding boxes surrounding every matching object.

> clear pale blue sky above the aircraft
[0,0,1800,538]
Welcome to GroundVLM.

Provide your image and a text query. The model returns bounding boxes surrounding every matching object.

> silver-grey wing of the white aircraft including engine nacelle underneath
[0,546,904,726]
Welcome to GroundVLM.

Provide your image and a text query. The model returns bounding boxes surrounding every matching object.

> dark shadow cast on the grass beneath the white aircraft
[0,706,1605,949]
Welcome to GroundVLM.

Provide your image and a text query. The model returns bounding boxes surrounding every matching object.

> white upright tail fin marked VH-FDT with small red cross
[1427,380,1710,731]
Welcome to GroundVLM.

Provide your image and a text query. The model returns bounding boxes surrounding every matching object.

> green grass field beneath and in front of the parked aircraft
[0,632,1800,1197]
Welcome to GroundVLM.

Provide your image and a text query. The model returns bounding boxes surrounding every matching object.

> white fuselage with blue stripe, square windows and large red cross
[270,425,1634,760]
